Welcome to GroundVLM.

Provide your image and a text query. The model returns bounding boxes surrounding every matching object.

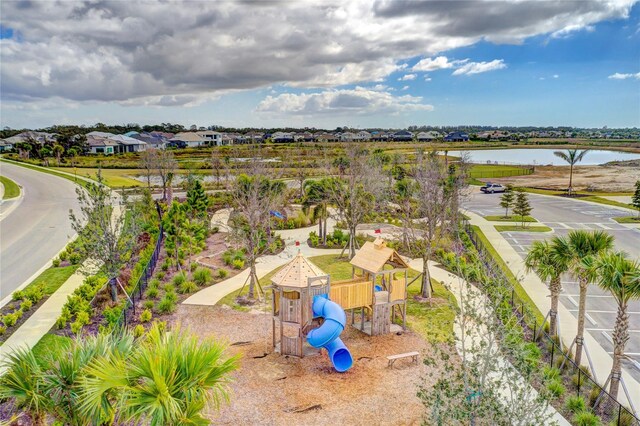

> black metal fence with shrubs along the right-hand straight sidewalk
[464,220,640,426]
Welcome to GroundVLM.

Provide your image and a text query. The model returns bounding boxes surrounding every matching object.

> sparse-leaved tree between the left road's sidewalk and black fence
[69,169,139,301]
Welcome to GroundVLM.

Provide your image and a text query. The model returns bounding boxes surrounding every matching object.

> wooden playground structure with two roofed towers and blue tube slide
[271,239,408,372]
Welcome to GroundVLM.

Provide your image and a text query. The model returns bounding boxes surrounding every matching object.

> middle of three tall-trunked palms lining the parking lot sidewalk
[554,231,613,365]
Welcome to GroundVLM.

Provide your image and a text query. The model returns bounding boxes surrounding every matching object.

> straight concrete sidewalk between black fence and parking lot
[465,211,640,409]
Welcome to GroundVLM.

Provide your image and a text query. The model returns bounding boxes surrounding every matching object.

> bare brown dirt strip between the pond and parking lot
[483,166,640,192]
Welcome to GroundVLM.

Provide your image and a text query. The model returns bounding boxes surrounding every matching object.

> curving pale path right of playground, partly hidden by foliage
[409,259,571,426]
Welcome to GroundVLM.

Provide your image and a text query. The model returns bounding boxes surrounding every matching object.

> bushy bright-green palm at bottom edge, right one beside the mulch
[78,325,237,425]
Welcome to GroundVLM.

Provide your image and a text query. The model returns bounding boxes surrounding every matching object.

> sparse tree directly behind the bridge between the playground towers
[327,145,385,259]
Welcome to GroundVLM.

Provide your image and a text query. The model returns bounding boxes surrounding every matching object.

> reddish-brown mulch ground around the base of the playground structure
[174,305,448,425]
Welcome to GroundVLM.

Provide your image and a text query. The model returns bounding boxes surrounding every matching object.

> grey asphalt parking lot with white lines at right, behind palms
[465,192,640,380]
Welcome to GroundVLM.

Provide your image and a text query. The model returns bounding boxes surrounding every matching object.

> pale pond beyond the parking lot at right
[449,148,640,166]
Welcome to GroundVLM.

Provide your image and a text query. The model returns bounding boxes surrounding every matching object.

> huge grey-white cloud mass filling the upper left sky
[0,0,634,105]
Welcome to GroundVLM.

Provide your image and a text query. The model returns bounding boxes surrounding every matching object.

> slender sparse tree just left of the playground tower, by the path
[229,156,285,300]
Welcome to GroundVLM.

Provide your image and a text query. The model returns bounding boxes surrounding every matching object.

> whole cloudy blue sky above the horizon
[0,0,640,129]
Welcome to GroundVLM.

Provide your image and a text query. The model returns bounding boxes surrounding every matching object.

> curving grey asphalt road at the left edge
[0,163,79,300]
